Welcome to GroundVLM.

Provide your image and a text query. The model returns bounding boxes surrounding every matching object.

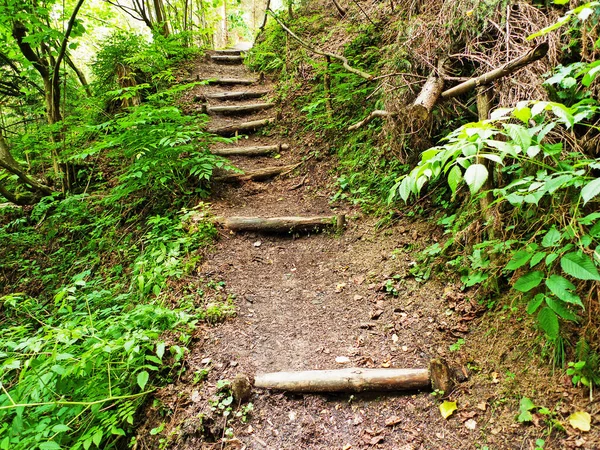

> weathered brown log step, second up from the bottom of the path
[214,215,345,234]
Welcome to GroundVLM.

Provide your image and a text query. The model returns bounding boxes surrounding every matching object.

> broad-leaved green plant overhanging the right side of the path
[390,100,600,342]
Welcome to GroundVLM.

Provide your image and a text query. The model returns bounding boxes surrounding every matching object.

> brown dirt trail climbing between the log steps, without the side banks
[136,51,572,450]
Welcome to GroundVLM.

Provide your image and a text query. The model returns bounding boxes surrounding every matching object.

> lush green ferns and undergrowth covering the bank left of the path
[0,29,235,450]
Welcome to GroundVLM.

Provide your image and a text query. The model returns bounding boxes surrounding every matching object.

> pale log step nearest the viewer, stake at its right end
[254,359,454,394]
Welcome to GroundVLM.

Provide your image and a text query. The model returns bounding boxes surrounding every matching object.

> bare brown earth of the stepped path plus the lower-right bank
[138,53,599,450]
